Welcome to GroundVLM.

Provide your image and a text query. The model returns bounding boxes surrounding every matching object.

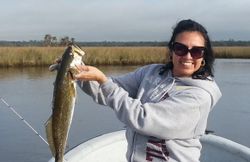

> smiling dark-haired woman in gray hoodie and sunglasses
[76,20,221,162]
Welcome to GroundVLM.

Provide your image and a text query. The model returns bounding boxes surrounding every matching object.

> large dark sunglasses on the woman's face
[172,42,206,59]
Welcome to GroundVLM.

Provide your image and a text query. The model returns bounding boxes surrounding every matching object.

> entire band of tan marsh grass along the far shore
[0,47,250,67]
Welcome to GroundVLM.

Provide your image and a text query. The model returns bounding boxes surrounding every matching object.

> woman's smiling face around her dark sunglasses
[171,31,205,77]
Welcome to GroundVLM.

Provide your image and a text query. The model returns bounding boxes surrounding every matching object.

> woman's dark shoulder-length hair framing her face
[162,19,214,79]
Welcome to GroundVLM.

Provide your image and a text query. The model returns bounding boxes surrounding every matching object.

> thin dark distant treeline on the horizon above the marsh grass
[0,40,250,47]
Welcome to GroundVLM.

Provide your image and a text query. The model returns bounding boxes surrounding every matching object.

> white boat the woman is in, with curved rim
[49,130,250,162]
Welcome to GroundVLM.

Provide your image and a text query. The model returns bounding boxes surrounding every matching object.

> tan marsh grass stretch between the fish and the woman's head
[84,47,167,65]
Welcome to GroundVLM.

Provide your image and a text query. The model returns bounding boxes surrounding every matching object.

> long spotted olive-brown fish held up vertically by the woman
[45,44,85,162]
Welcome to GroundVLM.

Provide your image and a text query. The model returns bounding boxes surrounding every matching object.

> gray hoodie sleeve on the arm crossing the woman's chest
[101,80,211,139]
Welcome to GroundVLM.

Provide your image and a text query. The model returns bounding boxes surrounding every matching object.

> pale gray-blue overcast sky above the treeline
[0,0,250,41]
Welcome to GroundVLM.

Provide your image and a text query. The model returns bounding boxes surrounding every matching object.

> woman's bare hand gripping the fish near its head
[75,65,108,84]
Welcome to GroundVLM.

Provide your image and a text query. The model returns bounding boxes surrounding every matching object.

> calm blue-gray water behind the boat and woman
[0,59,250,162]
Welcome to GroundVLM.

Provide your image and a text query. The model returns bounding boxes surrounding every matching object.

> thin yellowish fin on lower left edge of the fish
[45,117,56,157]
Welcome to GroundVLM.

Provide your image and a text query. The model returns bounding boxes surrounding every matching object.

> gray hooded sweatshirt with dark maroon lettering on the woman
[78,64,221,162]
